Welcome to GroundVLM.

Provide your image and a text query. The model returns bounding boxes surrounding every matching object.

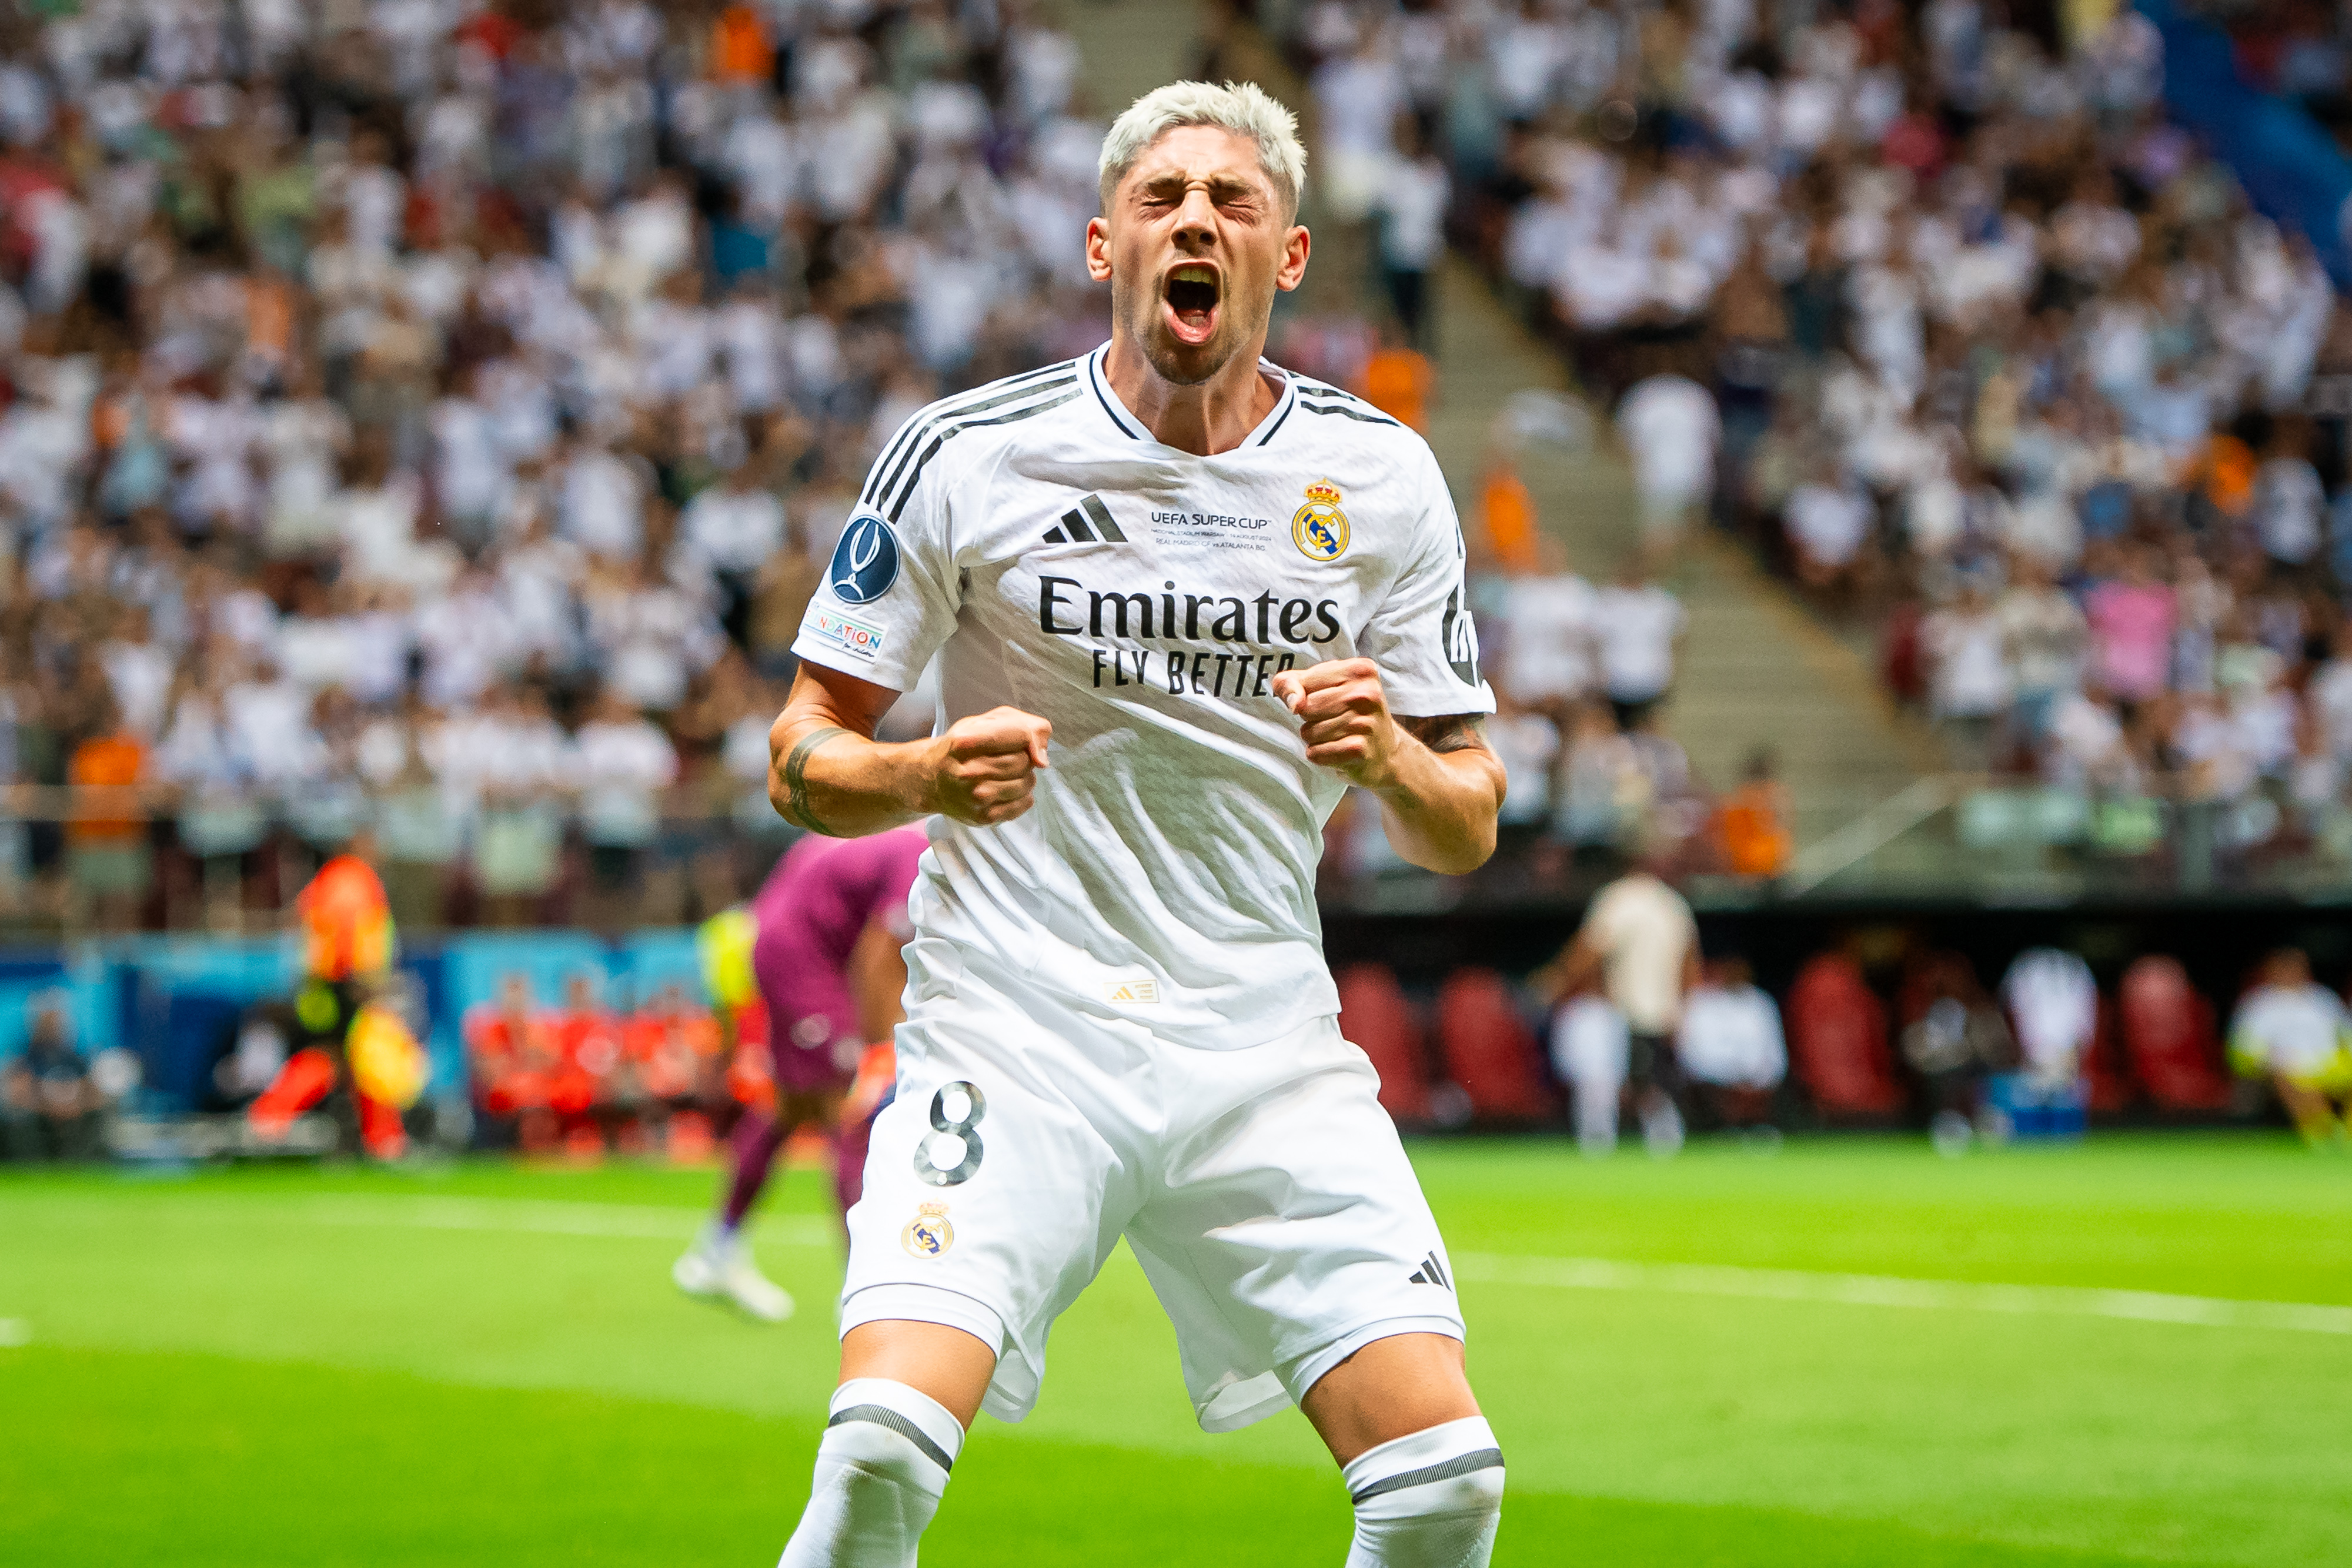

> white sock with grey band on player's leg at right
[1341,1415,1503,1568]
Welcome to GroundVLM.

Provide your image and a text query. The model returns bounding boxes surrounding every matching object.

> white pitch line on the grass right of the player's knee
[1454,1253,2352,1335]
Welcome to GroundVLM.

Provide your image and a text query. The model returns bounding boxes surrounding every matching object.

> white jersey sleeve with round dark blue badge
[793,414,960,691]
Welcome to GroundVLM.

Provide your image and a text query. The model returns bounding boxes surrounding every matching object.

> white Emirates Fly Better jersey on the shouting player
[793,348,1494,1048]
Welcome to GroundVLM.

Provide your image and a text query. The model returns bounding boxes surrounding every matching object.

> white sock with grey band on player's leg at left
[776,1378,964,1568]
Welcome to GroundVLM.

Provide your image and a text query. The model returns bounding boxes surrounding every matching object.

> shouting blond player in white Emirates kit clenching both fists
[769,82,1503,1568]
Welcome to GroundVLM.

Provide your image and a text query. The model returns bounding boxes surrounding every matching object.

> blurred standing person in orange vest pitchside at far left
[245,830,426,1159]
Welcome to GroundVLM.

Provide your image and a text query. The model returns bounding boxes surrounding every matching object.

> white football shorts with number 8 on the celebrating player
[842,938,1463,1432]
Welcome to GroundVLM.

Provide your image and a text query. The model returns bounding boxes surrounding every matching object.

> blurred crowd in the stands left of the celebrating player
[0,0,1108,926]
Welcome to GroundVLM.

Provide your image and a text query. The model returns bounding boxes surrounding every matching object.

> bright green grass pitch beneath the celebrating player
[0,1138,2352,1568]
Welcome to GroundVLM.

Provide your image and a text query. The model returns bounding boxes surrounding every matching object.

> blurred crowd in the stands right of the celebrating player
[1261,0,2352,884]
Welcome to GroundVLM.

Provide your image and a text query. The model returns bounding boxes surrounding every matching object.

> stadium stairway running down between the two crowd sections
[1065,0,1943,858]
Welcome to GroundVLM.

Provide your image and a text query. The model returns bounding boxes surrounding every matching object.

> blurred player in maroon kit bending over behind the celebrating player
[670,825,929,1323]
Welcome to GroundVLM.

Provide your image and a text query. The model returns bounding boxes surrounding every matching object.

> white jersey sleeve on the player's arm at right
[1357,459,1494,720]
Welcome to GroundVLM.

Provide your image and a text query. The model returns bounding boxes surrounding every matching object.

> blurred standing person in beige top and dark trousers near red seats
[1534,851,1698,1154]
